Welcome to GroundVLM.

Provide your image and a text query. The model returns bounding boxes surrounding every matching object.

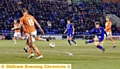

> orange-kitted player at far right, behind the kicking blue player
[105,16,116,49]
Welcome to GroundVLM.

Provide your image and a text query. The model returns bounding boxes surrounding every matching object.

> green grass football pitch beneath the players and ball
[0,40,120,69]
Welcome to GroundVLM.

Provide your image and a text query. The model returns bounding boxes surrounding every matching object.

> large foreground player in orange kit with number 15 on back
[12,8,44,59]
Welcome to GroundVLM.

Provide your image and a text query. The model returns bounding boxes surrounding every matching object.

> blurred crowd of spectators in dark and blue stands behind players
[0,0,120,38]
